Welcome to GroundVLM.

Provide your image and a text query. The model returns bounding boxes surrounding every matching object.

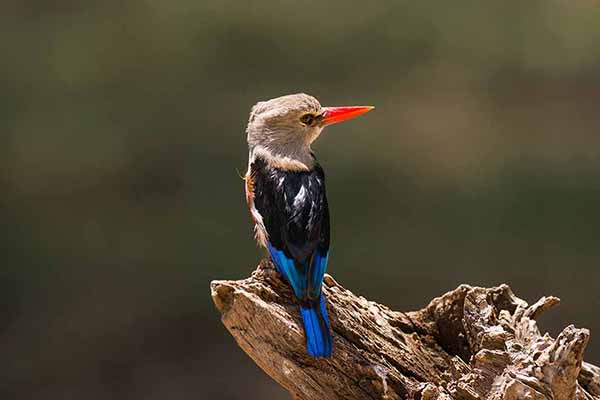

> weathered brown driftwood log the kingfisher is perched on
[211,261,600,400]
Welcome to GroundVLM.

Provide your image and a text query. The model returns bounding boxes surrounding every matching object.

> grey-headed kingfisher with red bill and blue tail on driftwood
[244,93,374,358]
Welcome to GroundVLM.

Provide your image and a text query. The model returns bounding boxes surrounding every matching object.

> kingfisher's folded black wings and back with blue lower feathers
[251,159,329,298]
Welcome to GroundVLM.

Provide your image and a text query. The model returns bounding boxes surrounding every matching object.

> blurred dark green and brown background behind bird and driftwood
[0,0,600,400]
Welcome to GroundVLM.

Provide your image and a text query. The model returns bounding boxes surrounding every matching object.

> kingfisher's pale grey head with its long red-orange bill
[246,93,373,169]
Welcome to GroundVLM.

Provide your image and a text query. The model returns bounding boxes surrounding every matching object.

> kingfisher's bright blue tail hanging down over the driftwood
[300,295,333,357]
